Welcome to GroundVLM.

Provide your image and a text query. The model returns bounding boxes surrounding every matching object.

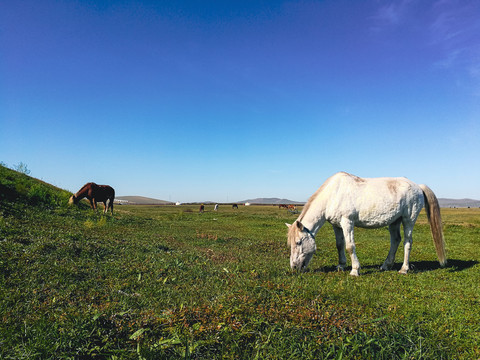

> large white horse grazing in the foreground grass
[286,172,446,276]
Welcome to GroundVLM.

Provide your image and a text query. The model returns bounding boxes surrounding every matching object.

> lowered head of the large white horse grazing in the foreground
[285,220,317,271]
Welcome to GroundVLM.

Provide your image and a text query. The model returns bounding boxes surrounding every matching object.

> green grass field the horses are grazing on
[0,167,480,359]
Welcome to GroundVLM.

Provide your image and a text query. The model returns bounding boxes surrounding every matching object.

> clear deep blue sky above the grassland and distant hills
[0,0,480,202]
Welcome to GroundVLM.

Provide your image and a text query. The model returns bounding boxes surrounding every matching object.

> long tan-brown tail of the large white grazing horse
[419,185,447,267]
